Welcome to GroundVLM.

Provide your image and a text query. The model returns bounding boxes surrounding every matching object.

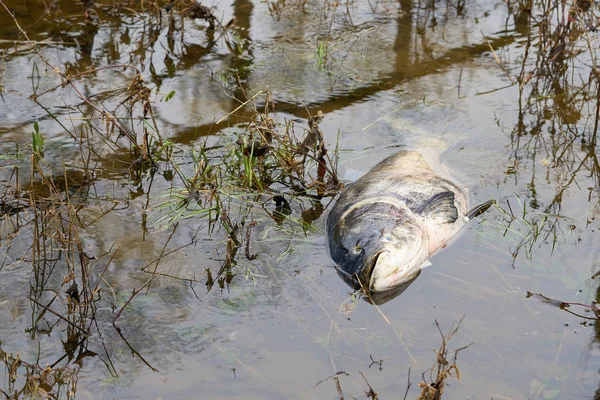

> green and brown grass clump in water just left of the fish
[156,99,341,289]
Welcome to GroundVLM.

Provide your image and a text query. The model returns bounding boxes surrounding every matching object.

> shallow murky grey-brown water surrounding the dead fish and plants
[0,0,600,399]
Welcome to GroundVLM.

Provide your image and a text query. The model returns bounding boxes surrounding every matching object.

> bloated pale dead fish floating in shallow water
[327,151,493,293]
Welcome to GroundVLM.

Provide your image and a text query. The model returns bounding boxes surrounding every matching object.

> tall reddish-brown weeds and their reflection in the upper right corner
[490,0,600,268]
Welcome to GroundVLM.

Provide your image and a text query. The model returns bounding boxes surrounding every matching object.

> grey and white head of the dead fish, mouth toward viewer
[330,202,429,292]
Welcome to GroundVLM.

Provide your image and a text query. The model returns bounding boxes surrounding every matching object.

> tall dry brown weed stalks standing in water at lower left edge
[0,149,116,399]
